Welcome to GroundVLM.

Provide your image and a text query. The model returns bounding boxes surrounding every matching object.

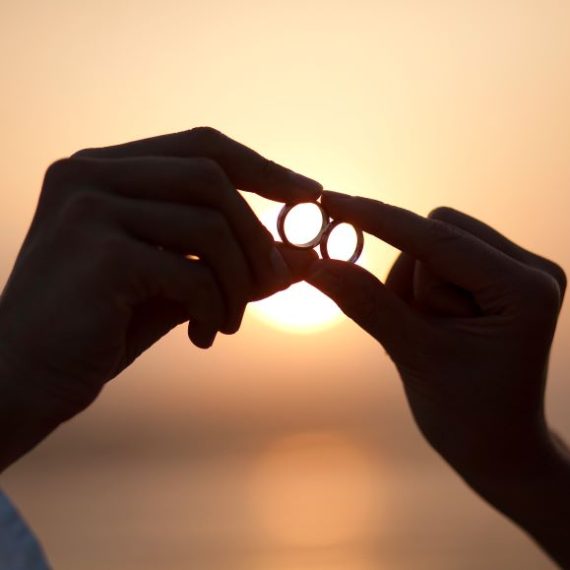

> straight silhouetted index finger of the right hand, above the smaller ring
[322,191,525,304]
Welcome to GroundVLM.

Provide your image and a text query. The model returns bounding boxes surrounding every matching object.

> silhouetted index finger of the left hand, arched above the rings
[74,127,323,203]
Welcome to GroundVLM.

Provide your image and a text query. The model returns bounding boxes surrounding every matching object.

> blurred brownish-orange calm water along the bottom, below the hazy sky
[4,424,554,570]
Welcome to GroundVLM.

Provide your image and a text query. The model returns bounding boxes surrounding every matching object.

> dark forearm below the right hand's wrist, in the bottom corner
[468,426,570,568]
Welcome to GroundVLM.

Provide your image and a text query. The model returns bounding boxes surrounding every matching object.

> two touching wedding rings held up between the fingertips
[277,202,364,263]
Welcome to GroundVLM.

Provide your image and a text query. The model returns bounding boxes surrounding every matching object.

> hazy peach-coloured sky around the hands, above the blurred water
[0,0,570,568]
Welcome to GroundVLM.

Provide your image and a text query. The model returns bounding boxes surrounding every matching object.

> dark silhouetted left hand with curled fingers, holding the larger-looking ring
[0,128,321,468]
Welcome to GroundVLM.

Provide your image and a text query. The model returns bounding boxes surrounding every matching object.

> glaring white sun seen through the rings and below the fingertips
[248,196,362,334]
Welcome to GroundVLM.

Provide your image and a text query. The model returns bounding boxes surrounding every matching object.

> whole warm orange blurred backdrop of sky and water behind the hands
[0,0,570,570]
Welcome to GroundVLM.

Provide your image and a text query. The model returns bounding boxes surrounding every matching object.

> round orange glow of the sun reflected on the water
[246,432,376,548]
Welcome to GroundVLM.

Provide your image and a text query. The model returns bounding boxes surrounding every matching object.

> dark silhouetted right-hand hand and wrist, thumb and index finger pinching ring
[308,192,570,564]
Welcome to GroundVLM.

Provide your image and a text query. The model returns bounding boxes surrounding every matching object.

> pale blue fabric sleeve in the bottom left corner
[0,491,50,570]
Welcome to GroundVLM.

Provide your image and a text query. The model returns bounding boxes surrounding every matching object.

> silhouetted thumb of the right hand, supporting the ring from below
[307,260,427,359]
